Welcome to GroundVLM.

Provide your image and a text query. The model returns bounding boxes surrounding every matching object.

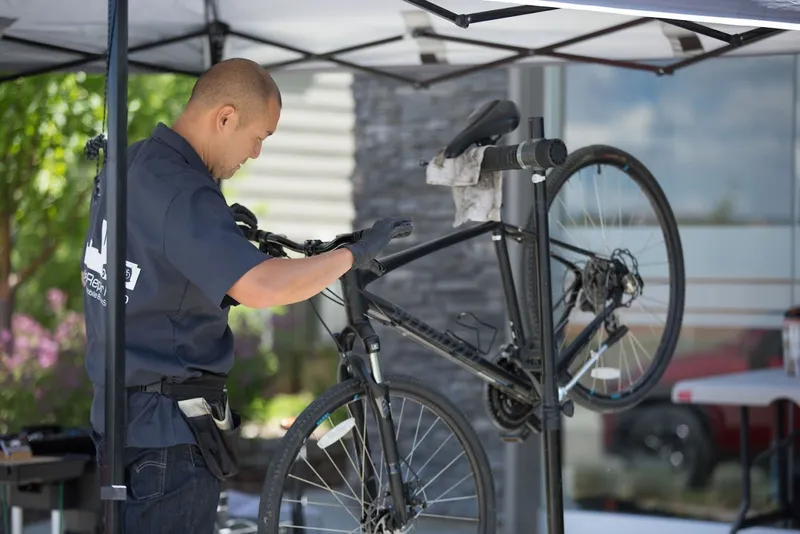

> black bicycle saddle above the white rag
[444,100,519,158]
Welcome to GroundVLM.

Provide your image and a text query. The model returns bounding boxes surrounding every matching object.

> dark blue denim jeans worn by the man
[95,437,221,534]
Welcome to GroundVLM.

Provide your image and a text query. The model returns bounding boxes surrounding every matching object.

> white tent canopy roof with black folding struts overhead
[0,0,800,85]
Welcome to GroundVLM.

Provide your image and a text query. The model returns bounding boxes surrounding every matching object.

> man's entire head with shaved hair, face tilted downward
[173,58,283,180]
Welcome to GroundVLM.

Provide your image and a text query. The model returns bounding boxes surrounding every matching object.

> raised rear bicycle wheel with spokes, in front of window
[524,145,685,412]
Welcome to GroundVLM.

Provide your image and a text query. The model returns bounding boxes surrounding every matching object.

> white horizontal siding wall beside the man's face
[225,71,354,240]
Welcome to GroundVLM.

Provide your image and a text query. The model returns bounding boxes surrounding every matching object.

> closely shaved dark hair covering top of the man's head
[187,58,283,125]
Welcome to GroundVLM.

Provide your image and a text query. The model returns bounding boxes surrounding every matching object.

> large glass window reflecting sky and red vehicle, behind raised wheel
[551,55,800,521]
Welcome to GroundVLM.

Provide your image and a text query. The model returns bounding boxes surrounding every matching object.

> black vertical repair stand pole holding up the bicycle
[528,117,564,534]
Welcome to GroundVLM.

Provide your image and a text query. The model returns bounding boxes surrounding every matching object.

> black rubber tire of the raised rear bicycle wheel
[523,145,686,413]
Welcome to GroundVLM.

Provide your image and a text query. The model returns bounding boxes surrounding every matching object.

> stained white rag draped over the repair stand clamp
[425,146,503,226]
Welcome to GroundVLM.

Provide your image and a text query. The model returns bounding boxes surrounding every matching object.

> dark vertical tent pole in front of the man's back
[100,0,128,534]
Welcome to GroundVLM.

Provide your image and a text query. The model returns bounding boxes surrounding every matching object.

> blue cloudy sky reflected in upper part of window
[565,56,795,224]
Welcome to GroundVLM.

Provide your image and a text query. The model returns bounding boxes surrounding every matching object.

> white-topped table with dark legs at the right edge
[672,368,800,534]
